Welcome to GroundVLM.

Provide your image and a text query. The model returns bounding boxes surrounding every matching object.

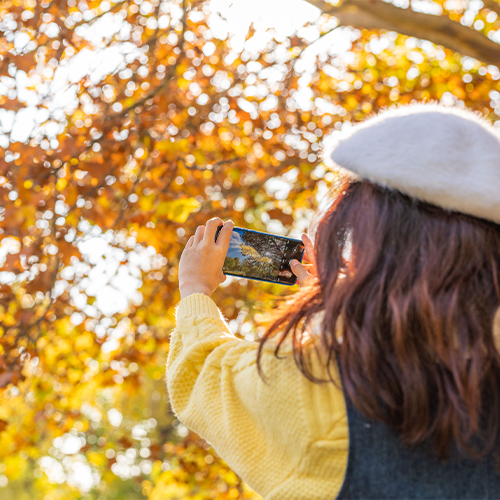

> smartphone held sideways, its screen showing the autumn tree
[215,226,304,286]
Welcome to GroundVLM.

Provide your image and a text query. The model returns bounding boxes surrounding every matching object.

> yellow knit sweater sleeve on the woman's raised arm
[167,294,349,500]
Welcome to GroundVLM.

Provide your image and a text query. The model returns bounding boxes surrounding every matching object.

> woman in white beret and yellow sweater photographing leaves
[167,104,500,500]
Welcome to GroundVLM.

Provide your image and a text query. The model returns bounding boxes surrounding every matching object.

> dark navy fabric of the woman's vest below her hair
[337,384,500,500]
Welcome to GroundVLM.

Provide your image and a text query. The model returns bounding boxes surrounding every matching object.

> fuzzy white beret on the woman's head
[324,103,500,224]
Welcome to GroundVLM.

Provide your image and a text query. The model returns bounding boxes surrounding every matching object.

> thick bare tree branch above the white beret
[305,0,500,66]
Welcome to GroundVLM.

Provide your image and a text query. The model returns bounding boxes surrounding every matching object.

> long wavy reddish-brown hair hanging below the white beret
[258,178,500,459]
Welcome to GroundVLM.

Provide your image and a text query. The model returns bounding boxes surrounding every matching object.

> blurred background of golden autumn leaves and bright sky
[0,0,500,500]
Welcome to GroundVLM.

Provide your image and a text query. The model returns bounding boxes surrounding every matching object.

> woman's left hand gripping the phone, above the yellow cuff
[179,217,234,299]
